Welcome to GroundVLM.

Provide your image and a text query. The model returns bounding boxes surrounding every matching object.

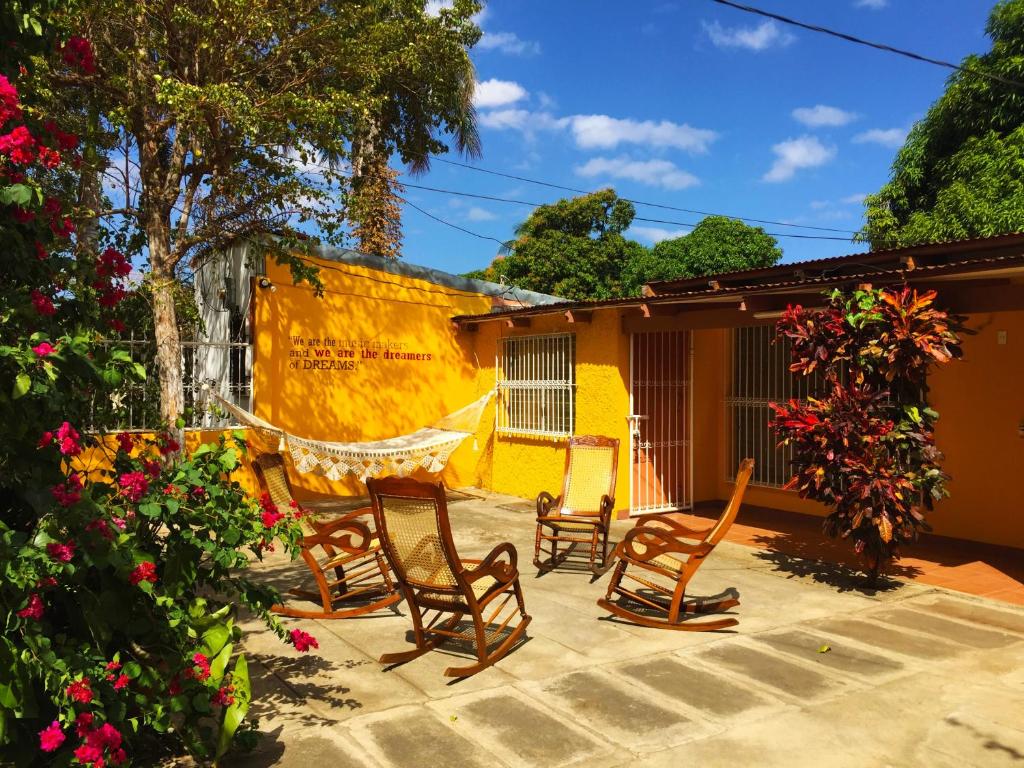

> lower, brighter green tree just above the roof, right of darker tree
[623,216,782,294]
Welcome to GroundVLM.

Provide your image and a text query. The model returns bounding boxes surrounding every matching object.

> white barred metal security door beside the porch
[629,331,693,514]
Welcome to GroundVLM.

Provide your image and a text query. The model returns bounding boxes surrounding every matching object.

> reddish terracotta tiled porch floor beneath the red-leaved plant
[671,507,1024,605]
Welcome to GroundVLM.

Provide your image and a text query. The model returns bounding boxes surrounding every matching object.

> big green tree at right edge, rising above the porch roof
[860,0,1024,248]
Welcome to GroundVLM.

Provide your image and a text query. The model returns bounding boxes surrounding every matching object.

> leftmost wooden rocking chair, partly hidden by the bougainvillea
[252,454,401,618]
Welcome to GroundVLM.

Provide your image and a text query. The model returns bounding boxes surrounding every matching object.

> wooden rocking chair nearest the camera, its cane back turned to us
[367,477,530,677]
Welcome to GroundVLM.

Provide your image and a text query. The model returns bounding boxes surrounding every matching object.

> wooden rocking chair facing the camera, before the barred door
[534,435,618,575]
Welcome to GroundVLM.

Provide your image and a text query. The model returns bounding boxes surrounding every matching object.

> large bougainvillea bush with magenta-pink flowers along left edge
[0,27,315,768]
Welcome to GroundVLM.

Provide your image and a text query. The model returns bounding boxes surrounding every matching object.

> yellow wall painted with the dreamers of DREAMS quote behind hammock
[253,260,494,497]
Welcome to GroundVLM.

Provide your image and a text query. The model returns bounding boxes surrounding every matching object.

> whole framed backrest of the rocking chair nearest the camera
[367,477,460,591]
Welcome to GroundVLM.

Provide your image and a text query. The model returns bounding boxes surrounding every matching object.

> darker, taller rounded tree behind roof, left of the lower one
[483,189,646,300]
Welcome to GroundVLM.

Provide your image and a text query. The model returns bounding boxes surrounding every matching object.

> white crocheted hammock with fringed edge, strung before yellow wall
[211,391,495,480]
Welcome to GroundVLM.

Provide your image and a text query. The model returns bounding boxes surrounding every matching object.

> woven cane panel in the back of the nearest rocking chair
[368,478,458,590]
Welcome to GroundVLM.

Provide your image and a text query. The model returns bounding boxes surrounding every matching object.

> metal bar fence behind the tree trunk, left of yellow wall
[91,335,253,430]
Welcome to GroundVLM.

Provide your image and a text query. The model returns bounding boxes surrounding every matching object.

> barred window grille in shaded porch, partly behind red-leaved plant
[725,326,821,487]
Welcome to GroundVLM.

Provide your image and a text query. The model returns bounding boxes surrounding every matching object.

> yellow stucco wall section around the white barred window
[473,310,630,512]
